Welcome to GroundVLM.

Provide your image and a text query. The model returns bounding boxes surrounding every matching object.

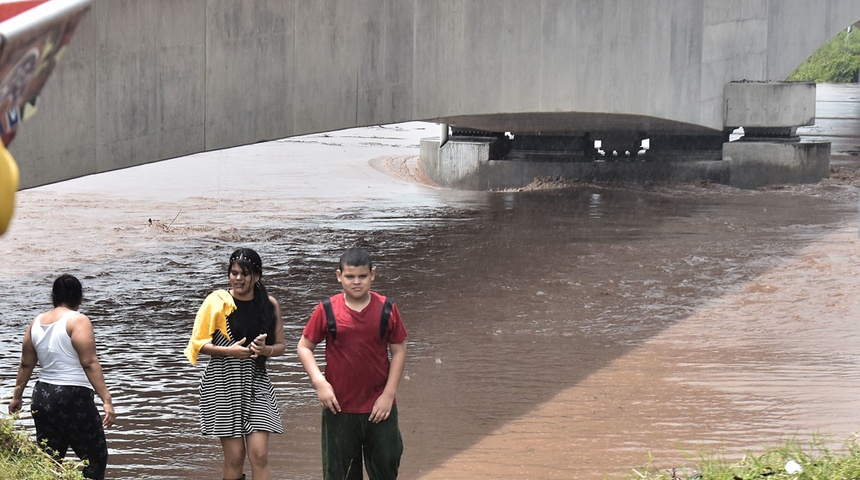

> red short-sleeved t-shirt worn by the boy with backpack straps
[302,292,406,413]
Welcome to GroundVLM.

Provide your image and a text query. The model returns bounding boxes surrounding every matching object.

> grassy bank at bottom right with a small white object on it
[629,435,860,480]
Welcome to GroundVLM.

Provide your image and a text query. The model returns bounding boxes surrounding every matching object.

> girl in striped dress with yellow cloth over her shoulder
[185,248,285,480]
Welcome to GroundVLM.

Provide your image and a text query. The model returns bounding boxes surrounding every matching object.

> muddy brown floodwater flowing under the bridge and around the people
[0,85,860,479]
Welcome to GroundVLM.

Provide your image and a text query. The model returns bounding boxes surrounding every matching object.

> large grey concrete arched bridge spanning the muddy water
[11,0,860,188]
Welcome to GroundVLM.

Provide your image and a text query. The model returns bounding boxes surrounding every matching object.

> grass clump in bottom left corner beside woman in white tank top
[0,417,84,480]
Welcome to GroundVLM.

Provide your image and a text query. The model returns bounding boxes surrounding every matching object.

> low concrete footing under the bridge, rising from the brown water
[421,138,830,190]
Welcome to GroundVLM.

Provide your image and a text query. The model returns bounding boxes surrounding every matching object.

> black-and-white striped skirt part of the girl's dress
[200,306,284,437]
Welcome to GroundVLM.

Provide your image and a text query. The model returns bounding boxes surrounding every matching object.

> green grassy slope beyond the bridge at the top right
[788,26,860,83]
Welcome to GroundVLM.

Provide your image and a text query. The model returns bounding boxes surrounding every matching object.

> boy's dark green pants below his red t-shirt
[322,405,403,480]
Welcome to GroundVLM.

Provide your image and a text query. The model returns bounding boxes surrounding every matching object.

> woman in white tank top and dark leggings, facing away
[9,274,116,479]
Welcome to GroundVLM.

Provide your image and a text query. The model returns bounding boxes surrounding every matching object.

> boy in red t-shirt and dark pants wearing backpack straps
[298,248,406,480]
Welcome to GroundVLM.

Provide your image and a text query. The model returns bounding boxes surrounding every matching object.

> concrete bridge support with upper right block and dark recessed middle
[420,82,830,190]
